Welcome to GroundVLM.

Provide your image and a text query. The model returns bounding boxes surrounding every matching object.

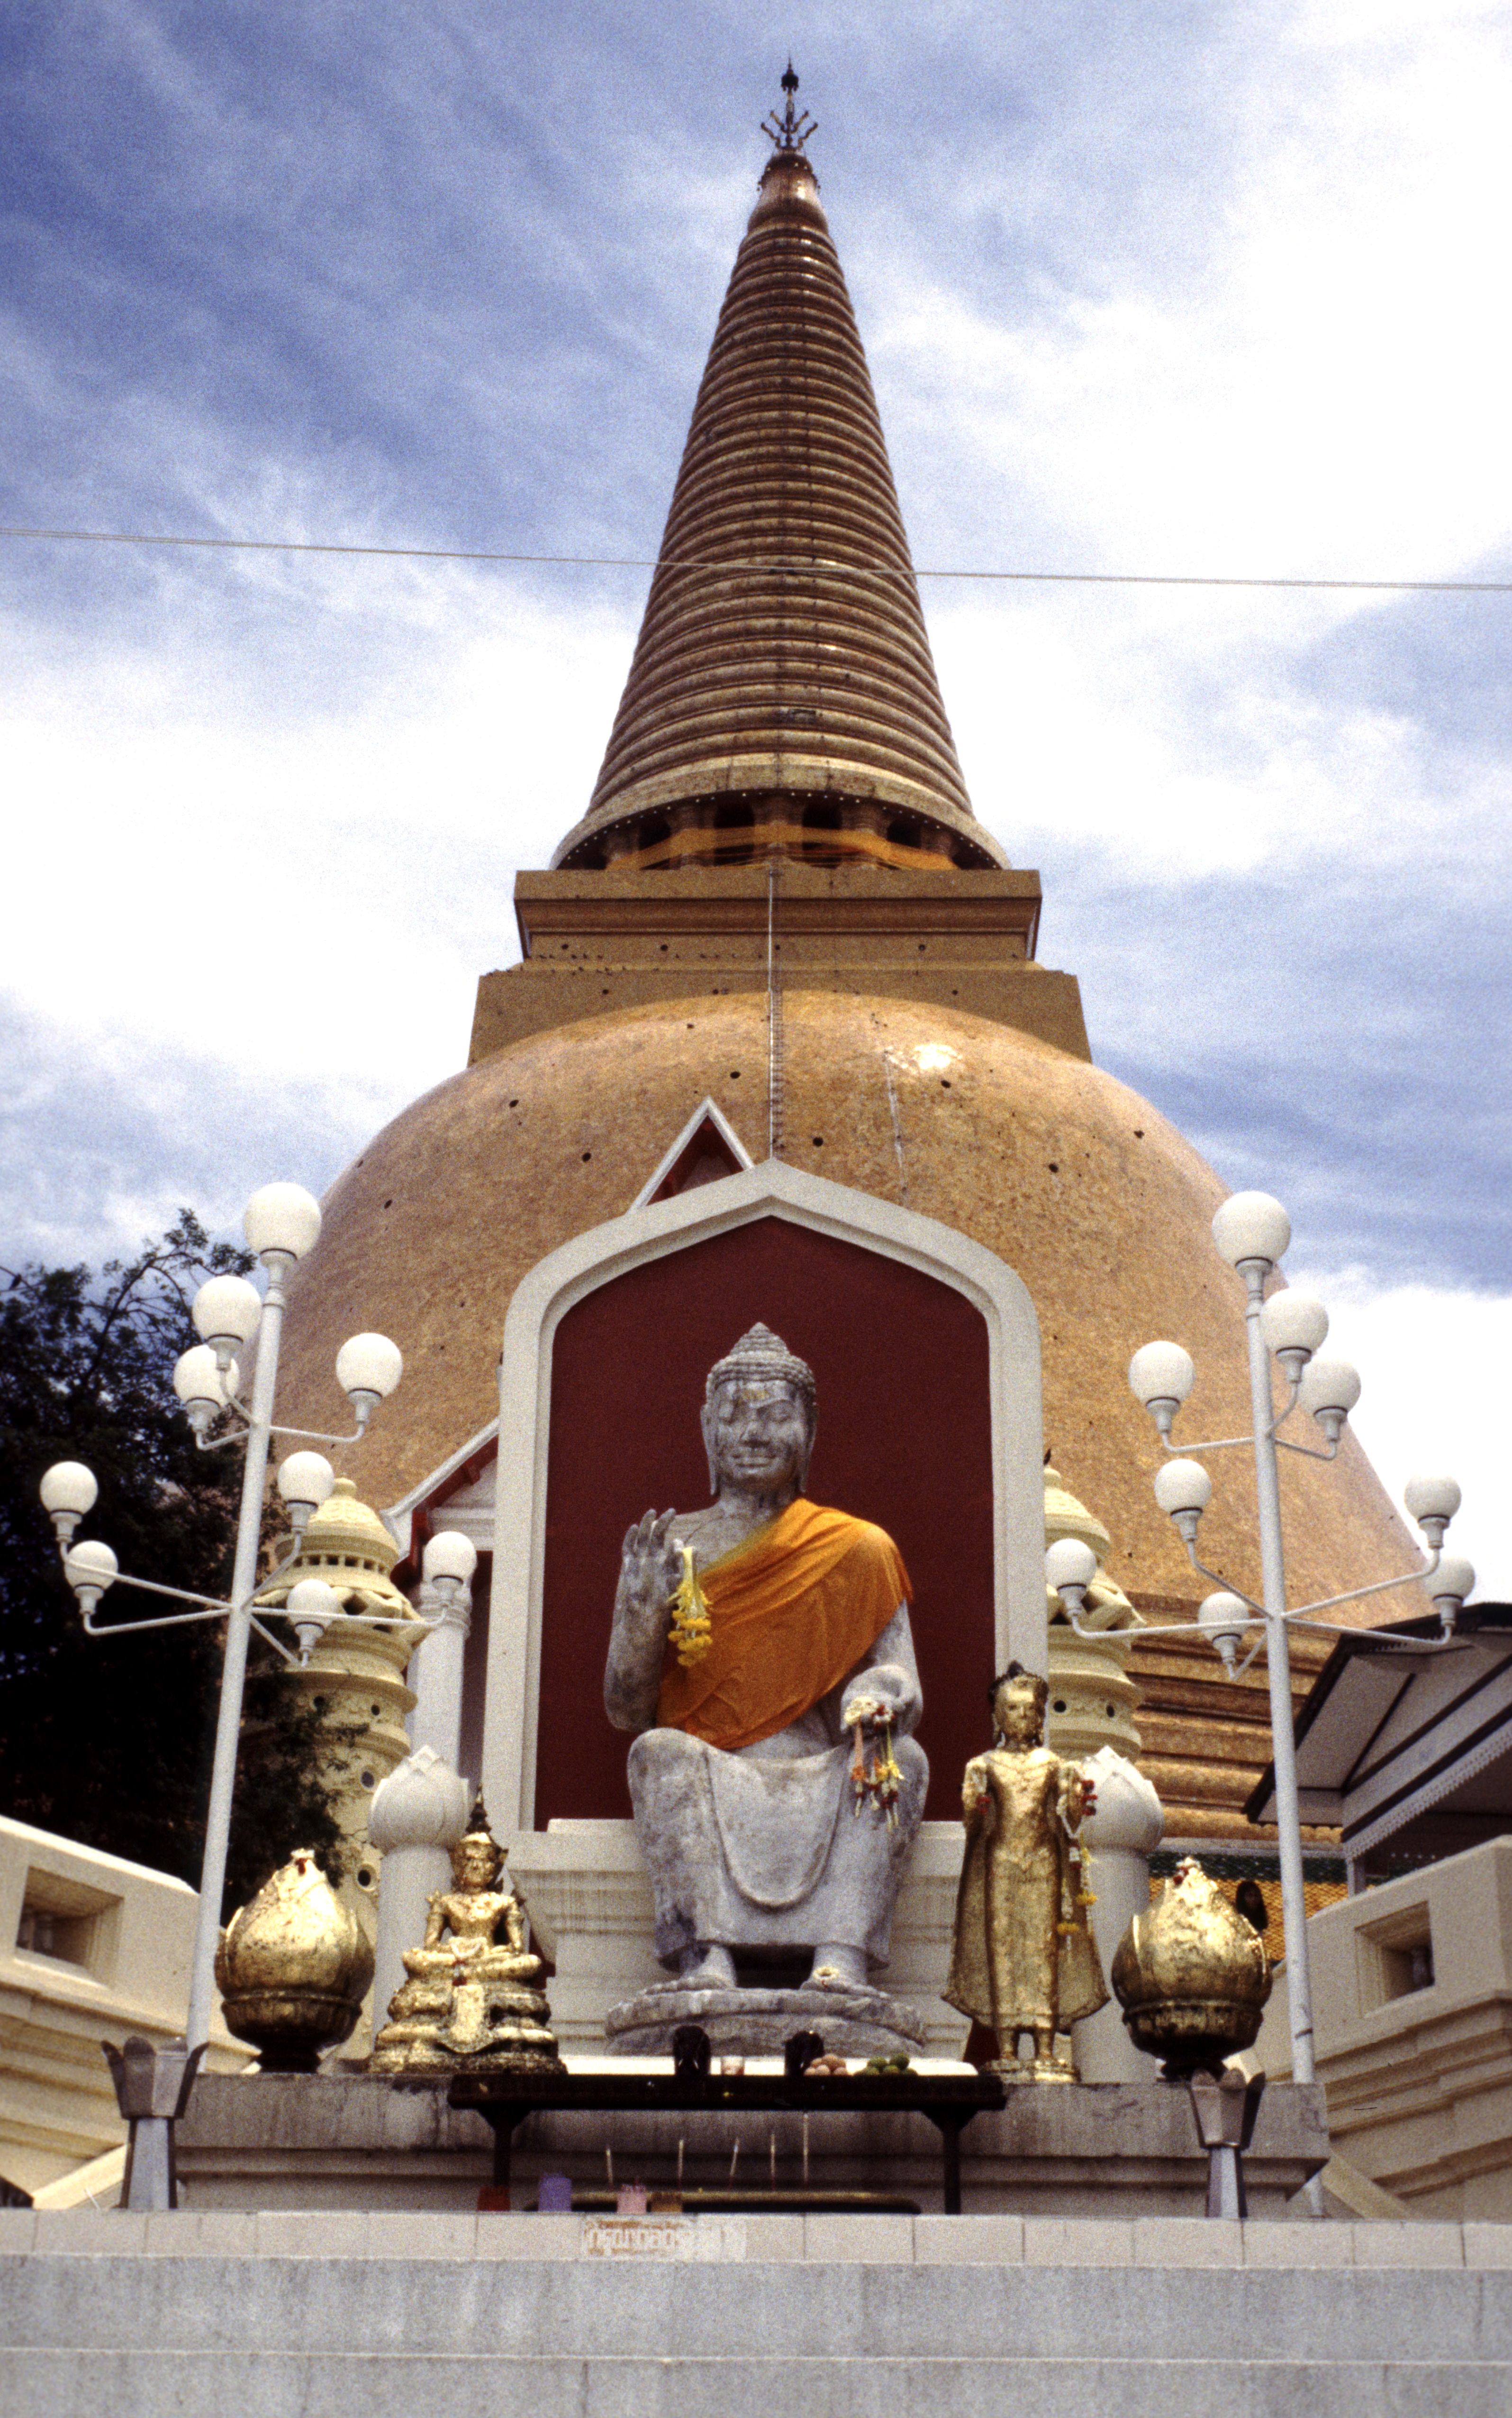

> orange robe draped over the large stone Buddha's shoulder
[656,1497,912,1753]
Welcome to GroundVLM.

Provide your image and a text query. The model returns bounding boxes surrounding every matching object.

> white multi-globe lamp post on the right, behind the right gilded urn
[1045,1192,1476,2118]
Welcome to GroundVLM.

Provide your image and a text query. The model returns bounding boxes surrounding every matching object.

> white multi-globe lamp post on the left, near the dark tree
[41,1185,477,2050]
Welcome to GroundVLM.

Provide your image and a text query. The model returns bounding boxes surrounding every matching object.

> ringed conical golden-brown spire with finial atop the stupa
[552,63,1004,870]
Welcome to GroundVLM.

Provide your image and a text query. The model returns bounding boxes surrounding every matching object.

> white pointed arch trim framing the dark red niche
[484,1158,1045,1838]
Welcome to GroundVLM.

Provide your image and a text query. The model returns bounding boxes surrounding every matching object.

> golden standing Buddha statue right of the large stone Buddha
[943,1664,1108,2082]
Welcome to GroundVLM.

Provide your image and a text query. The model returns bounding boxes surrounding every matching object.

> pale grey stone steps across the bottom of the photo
[0,2210,1512,2418]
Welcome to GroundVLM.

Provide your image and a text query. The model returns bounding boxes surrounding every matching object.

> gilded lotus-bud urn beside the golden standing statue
[1108,1857,1270,2082]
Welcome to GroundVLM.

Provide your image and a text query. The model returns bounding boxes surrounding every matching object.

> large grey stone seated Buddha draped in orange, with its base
[605,1325,929,2053]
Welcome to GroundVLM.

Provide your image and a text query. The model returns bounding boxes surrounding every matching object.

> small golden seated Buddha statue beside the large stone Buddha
[368,1799,561,2074]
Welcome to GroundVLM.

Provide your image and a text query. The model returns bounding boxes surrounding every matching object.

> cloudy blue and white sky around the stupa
[0,0,1512,1598]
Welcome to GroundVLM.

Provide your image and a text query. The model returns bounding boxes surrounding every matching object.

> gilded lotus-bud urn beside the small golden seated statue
[215,1847,372,2074]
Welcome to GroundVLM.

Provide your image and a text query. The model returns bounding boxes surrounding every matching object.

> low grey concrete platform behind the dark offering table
[177,2074,1328,2217]
